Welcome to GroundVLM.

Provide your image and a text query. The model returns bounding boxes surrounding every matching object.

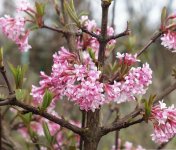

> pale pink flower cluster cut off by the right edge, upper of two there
[161,30,176,52]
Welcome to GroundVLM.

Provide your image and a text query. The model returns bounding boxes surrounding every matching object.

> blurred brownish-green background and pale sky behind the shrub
[0,0,176,150]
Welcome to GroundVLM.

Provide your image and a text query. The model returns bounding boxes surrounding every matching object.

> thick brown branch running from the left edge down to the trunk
[0,97,84,135]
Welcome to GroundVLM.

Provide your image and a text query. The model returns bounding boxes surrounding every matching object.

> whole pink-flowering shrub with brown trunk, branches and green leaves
[0,0,176,150]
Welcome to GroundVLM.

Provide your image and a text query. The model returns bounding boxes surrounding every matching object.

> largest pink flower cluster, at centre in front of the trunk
[31,47,105,111]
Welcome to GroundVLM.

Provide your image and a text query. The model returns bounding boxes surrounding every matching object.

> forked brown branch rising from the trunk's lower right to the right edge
[101,82,176,135]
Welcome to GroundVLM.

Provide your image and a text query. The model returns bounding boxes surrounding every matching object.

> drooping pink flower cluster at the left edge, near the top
[0,15,31,52]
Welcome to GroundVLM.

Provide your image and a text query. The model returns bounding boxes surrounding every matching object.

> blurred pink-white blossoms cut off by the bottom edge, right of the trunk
[111,139,145,150]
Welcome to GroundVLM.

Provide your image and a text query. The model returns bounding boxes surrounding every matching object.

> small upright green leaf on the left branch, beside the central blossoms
[41,90,53,111]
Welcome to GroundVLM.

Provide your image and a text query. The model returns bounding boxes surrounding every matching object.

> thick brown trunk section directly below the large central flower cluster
[84,110,101,150]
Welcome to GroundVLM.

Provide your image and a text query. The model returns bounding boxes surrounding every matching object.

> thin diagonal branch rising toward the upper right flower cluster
[137,31,163,57]
